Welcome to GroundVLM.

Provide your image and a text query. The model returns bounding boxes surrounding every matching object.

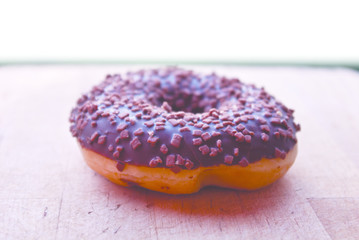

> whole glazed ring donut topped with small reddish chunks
[70,67,300,194]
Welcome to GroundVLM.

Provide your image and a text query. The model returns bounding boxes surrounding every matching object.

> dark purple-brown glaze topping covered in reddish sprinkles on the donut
[70,68,300,172]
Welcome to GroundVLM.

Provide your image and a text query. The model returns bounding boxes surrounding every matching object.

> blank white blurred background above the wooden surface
[0,0,359,68]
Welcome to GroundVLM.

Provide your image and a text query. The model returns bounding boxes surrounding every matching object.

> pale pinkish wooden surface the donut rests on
[0,66,359,240]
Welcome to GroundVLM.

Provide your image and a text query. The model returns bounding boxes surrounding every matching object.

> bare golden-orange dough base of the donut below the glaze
[80,144,298,194]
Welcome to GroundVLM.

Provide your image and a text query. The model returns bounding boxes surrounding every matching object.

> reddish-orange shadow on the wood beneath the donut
[97,172,295,218]
